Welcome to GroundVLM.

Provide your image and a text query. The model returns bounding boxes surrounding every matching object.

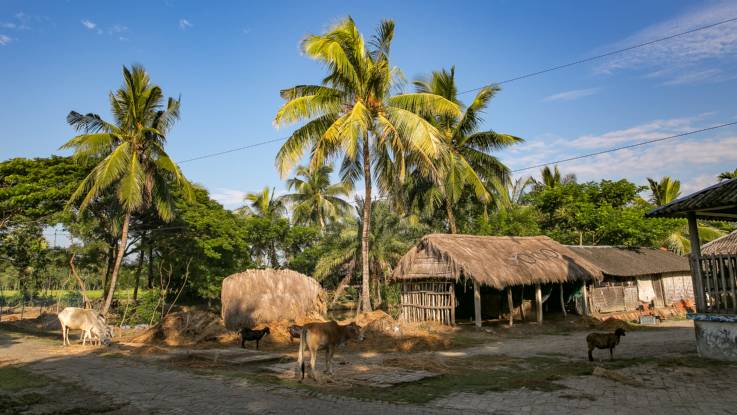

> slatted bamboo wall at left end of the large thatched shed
[400,281,456,325]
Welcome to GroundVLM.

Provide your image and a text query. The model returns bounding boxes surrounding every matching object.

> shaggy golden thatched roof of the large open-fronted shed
[392,234,601,289]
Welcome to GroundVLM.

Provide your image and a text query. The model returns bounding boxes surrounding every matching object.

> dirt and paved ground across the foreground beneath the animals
[0,320,737,414]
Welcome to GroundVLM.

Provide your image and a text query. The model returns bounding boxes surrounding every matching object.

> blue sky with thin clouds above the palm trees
[0,0,737,208]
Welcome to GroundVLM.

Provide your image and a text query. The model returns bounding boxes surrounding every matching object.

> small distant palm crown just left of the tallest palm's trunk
[283,165,351,230]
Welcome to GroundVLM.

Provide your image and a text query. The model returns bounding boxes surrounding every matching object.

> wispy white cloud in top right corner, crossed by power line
[597,1,737,79]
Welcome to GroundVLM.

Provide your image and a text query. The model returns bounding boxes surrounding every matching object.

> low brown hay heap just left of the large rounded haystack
[131,309,228,346]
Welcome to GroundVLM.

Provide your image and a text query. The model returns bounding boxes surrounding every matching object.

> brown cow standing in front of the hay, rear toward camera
[297,321,363,382]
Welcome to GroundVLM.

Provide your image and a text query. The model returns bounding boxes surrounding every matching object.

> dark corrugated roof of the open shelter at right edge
[645,178,737,221]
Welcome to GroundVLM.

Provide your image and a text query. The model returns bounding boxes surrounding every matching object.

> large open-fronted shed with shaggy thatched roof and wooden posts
[392,234,602,326]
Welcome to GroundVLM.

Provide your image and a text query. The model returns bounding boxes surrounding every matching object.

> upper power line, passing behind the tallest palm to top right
[178,17,737,163]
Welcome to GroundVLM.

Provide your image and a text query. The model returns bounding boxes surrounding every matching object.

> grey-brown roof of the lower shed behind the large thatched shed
[568,246,690,277]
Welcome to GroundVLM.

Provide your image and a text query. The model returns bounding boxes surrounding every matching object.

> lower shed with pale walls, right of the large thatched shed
[569,246,693,313]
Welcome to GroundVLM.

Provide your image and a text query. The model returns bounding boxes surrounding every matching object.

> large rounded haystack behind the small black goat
[220,269,326,330]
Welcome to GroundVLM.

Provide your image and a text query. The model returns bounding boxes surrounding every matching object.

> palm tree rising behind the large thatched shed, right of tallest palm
[402,67,524,234]
